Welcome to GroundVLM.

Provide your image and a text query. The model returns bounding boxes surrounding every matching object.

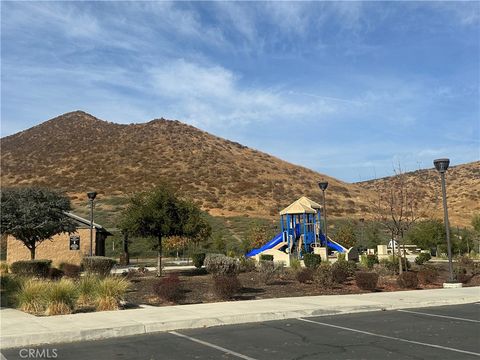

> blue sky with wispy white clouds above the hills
[1,1,480,182]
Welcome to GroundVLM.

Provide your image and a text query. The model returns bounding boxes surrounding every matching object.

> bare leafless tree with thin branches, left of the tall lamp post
[371,164,425,274]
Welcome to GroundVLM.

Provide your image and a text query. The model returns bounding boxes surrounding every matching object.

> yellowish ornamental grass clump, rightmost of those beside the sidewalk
[95,276,130,311]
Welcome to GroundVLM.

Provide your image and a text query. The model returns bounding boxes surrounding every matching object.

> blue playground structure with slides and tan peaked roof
[245,196,353,266]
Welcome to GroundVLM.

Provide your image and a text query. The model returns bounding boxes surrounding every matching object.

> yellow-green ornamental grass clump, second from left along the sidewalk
[45,279,78,315]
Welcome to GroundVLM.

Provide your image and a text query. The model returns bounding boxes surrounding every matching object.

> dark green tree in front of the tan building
[1,187,76,260]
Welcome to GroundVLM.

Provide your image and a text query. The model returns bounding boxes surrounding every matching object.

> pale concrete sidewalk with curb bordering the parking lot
[0,287,480,348]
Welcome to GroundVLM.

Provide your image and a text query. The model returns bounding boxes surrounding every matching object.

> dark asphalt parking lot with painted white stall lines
[2,303,480,360]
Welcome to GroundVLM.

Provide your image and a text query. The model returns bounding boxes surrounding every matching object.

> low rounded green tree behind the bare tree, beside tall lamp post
[405,219,446,249]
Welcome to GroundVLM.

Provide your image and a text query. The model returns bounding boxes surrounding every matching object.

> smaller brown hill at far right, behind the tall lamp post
[357,161,480,226]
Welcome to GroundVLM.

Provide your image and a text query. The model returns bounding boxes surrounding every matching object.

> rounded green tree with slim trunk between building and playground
[120,185,211,276]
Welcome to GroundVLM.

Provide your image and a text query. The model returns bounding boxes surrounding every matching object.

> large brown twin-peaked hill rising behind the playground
[1,111,368,217]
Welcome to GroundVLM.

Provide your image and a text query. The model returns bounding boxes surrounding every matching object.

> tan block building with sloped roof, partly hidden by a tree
[7,213,112,266]
